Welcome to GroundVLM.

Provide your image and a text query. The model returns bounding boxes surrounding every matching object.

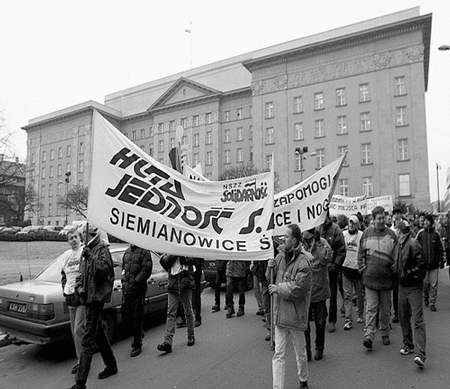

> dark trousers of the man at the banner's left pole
[76,303,117,387]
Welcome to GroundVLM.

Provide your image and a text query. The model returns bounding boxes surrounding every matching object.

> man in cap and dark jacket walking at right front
[396,219,426,368]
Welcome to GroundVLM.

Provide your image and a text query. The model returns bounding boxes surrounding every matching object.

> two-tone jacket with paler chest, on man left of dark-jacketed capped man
[358,226,398,290]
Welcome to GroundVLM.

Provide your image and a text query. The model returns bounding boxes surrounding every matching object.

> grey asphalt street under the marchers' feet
[0,268,450,389]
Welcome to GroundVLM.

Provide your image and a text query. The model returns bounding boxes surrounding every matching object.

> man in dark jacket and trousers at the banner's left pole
[68,227,117,389]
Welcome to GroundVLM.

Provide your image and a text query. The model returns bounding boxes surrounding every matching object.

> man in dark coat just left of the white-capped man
[320,214,347,332]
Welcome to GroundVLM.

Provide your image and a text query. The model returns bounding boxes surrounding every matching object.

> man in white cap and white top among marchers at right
[342,215,364,331]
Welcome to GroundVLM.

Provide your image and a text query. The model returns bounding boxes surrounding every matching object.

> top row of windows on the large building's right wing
[264,76,406,119]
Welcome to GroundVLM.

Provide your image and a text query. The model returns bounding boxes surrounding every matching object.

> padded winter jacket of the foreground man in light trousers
[267,246,312,331]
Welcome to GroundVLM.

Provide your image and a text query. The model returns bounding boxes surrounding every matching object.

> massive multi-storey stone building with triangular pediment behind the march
[24,8,431,224]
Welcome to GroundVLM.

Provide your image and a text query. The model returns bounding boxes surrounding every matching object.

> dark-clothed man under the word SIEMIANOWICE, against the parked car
[122,245,153,357]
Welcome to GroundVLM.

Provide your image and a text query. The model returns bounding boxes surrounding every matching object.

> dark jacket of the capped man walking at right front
[396,233,427,286]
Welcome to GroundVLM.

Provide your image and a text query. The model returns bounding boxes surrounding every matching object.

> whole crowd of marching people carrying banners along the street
[61,207,450,389]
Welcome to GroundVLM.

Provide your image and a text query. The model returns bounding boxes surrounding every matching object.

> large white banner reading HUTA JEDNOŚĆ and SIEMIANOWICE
[88,112,273,260]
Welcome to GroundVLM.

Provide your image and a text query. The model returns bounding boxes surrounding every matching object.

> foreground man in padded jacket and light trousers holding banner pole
[268,224,312,389]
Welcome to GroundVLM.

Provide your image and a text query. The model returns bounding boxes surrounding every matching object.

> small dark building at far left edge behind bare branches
[0,154,25,226]
